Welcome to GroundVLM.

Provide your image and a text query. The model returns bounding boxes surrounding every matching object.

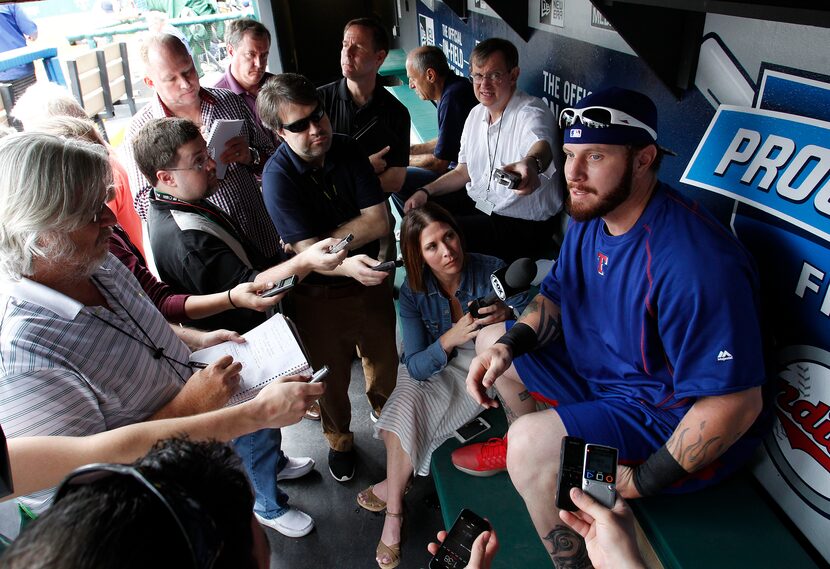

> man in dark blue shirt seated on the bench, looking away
[392,45,478,213]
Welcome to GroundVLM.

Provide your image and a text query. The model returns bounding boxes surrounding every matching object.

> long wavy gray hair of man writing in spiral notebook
[0,133,112,280]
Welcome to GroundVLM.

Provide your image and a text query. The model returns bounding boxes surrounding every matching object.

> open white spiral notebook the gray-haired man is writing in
[190,314,311,406]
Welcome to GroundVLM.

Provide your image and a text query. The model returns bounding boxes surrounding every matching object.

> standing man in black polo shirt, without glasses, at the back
[319,18,410,193]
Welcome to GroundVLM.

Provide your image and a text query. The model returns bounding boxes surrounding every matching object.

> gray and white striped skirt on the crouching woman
[374,342,483,476]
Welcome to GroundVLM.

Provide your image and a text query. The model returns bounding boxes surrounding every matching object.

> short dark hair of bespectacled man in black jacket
[133,117,202,187]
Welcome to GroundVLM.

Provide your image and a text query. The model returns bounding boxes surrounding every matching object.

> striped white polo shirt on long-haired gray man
[0,255,192,511]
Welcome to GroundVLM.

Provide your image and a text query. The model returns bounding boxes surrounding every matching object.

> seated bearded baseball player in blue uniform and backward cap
[462,88,769,567]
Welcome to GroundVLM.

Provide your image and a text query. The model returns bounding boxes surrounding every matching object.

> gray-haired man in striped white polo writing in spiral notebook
[0,133,256,511]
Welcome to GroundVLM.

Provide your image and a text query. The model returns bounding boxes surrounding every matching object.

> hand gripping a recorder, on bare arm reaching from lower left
[254,375,326,429]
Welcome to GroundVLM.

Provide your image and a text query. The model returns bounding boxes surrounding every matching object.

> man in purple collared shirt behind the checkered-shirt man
[214,18,279,147]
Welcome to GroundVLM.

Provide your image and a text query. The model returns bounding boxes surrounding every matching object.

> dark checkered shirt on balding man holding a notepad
[122,87,280,257]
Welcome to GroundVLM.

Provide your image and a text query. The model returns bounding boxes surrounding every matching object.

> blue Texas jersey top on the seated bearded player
[541,184,765,412]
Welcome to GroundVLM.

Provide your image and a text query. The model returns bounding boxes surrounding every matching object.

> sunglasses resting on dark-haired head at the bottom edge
[54,464,224,569]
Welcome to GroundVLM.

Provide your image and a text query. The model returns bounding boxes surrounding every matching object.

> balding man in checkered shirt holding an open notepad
[123,34,280,257]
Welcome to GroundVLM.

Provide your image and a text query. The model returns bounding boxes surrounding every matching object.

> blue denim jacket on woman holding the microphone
[400,253,528,381]
